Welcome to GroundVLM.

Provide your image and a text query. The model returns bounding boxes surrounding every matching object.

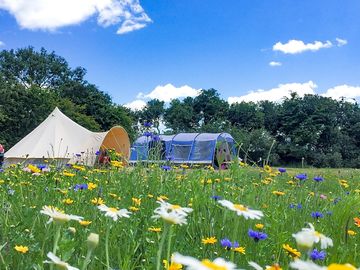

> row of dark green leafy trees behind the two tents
[0,47,360,168]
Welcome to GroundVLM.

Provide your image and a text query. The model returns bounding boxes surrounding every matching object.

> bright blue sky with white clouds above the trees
[0,0,360,108]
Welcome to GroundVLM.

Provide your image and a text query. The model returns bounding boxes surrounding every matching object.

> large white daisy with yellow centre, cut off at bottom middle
[172,253,237,270]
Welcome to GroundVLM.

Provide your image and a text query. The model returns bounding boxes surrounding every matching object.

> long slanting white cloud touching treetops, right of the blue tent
[228,81,317,104]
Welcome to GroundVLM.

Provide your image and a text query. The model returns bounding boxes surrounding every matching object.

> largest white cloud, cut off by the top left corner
[0,0,151,34]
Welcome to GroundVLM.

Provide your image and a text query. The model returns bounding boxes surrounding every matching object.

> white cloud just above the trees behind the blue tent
[137,83,200,102]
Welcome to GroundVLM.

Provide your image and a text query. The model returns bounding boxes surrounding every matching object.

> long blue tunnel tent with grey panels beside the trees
[130,133,236,164]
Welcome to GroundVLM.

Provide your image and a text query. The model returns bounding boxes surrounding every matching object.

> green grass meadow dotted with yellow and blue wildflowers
[0,161,360,270]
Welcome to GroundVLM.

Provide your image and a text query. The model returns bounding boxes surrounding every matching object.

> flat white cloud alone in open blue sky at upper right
[273,39,333,54]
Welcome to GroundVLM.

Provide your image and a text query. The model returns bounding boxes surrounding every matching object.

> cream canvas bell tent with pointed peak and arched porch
[5,108,130,166]
